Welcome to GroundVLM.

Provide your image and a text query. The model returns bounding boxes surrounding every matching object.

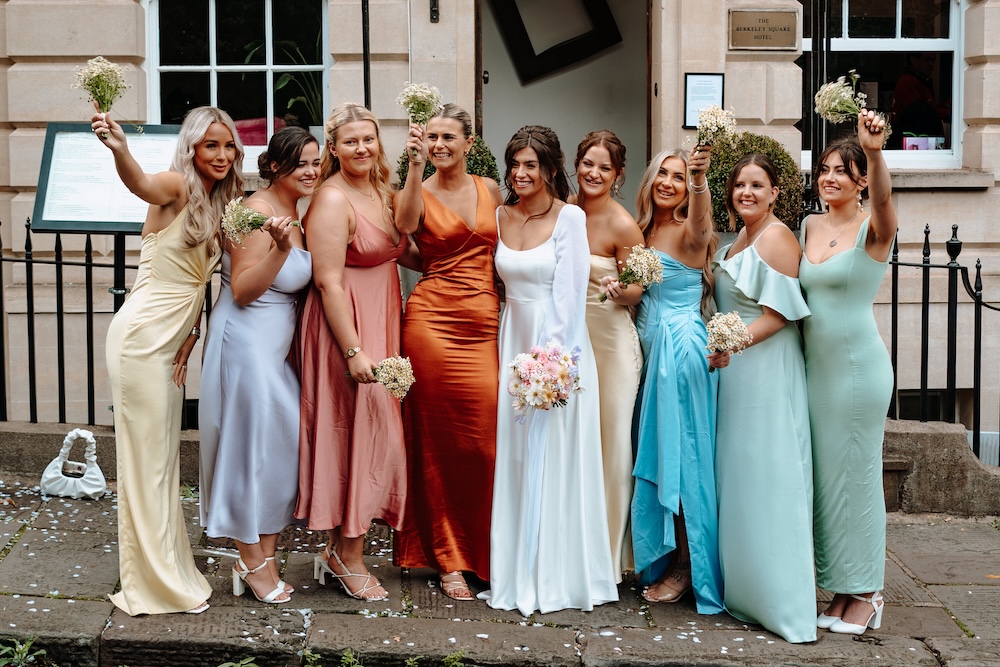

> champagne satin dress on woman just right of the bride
[587,255,642,583]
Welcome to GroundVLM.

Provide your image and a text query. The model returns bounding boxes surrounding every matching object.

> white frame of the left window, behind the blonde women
[142,0,332,166]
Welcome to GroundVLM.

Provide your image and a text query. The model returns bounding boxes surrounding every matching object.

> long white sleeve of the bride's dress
[538,204,590,347]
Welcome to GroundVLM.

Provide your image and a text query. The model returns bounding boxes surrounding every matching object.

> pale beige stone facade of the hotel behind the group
[0,0,1000,430]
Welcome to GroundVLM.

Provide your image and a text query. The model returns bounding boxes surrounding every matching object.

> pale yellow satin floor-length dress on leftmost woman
[105,208,221,616]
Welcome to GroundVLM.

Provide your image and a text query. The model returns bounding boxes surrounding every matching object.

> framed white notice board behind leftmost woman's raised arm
[31,123,180,234]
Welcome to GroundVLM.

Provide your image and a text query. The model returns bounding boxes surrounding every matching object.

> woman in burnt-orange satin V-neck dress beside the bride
[394,104,501,600]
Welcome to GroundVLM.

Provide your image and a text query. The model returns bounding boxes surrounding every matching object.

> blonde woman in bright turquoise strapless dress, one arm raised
[628,146,728,614]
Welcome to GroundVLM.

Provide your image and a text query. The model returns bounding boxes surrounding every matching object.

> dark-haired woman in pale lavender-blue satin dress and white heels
[199,127,319,603]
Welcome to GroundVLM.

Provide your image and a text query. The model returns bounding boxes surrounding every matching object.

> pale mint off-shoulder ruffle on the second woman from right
[712,246,812,322]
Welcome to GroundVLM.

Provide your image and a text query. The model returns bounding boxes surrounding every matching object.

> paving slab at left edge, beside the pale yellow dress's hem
[0,528,118,600]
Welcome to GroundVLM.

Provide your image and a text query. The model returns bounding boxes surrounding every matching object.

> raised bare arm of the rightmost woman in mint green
[858,110,899,260]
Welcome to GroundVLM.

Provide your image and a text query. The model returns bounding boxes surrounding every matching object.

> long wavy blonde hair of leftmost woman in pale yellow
[170,107,243,255]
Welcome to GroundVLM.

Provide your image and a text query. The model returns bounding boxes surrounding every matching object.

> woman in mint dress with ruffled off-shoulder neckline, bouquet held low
[709,154,816,642]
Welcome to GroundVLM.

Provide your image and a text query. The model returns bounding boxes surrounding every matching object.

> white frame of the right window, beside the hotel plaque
[802,0,968,170]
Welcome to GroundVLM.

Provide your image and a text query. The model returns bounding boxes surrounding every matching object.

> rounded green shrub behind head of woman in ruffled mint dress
[708,132,802,232]
